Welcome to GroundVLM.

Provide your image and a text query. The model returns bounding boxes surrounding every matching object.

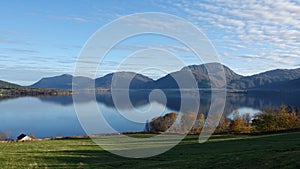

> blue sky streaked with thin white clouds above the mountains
[0,0,300,85]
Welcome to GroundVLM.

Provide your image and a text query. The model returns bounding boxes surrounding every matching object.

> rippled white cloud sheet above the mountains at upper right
[162,0,300,66]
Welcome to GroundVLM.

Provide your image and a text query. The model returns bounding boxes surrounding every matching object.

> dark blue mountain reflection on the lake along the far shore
[40,91,300,114]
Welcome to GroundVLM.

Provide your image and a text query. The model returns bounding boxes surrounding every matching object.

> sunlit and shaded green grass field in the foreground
[0,132,300,169]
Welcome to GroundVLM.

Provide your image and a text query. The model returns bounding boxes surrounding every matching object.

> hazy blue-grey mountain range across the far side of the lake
[0,63,300,91]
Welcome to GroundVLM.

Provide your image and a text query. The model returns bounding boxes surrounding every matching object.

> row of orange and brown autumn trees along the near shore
[145,105,300,134]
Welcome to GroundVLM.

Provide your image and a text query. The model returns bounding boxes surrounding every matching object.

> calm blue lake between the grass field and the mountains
[0,92,300,139]
